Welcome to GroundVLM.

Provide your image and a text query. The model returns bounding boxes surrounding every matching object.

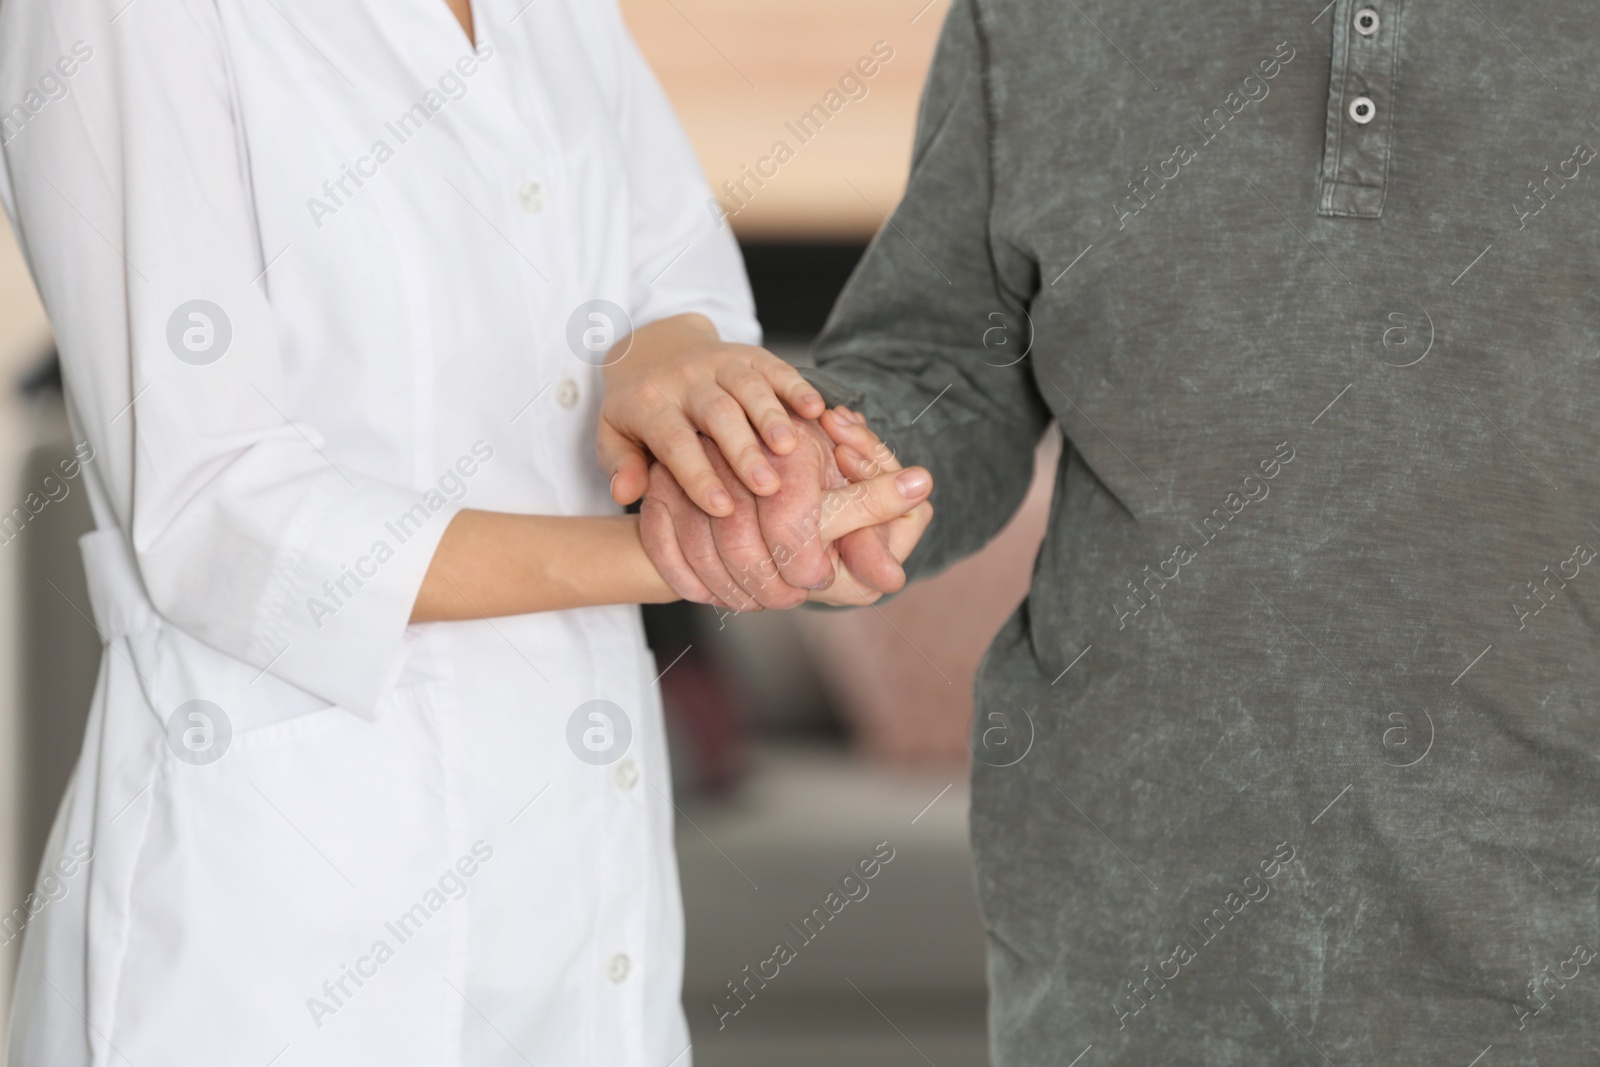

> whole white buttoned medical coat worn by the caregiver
[0,0,758,1067]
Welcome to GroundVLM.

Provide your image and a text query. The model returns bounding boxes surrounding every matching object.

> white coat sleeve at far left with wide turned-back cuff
[0,0,454,715]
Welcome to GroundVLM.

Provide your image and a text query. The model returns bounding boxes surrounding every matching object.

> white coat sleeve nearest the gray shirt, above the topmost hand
[600,0,762,344]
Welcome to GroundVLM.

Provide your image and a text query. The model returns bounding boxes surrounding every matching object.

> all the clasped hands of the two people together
[598,315,933,611]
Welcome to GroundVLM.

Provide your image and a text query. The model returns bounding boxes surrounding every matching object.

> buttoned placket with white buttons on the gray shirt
[1317,0,1402,219]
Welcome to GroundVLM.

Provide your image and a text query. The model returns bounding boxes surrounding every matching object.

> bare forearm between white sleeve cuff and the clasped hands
[411,510,678,622]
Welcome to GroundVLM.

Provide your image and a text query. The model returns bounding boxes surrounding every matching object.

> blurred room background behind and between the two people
[0,0,1054,1067]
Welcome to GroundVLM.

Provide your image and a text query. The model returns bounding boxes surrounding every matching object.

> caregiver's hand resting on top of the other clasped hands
[598,315,826,515]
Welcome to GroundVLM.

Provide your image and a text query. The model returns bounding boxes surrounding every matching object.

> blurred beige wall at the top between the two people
[622,0,949,238]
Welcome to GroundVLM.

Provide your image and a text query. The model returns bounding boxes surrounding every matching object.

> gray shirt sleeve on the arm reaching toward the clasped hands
[808,0,1050,576]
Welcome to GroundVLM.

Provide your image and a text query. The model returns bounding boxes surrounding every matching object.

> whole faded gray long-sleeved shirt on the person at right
[816,0,1600,1067]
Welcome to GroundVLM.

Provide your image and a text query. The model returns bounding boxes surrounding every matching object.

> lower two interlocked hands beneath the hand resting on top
[640,408,933,611]
